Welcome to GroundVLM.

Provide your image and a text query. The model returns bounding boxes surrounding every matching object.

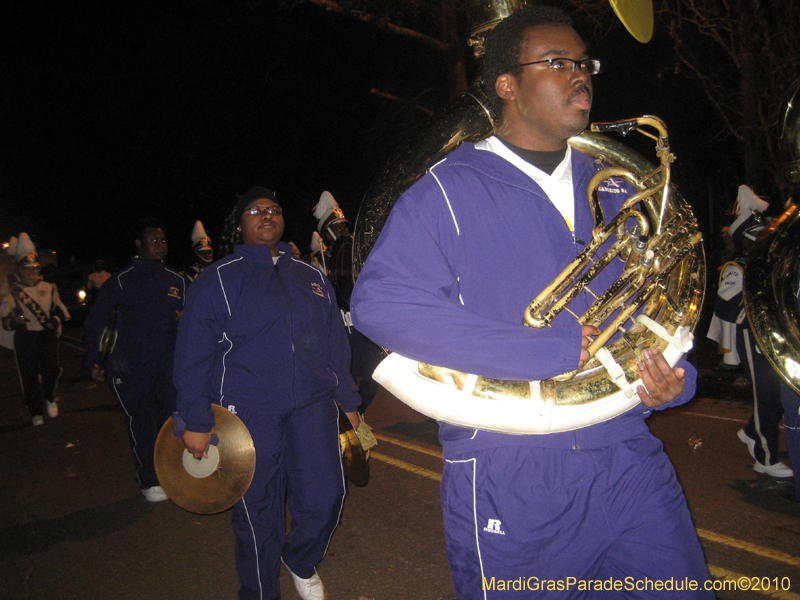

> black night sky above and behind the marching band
[0,0,736,267]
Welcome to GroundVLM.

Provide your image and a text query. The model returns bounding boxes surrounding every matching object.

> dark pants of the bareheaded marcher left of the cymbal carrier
[108,362,177,489]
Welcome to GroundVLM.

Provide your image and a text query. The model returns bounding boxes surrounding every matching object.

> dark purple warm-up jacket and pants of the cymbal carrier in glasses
[175,243,361,600]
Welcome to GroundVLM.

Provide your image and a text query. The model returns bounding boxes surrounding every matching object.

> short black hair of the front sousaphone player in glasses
[483,4,573,115]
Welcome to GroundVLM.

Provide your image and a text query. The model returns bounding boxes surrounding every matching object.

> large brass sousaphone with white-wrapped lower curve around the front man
[353,1,705,434]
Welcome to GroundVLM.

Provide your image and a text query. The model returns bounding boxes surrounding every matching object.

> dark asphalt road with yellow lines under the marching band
[0,328,800,600]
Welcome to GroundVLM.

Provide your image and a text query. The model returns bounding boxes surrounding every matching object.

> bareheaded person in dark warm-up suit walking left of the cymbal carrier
[84,218,186,502]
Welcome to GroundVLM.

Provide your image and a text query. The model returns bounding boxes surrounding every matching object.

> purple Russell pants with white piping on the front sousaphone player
[441,433,714,600]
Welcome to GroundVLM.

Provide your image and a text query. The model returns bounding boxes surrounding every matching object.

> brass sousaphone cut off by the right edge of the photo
[744,81,800,394]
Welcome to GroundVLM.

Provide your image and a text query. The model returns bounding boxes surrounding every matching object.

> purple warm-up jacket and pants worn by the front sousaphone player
[352,138,713,600]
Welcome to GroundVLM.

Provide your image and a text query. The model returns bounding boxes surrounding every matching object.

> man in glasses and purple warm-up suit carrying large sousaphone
[351,5,713,600]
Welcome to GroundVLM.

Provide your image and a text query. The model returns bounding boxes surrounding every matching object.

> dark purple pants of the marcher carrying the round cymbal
[226,398,345,600]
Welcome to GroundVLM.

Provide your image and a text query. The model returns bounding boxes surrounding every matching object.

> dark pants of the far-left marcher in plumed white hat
[14,329,61,417]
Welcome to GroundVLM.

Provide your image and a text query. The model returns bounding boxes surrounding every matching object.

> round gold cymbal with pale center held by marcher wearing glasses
[155,404,256,515]
